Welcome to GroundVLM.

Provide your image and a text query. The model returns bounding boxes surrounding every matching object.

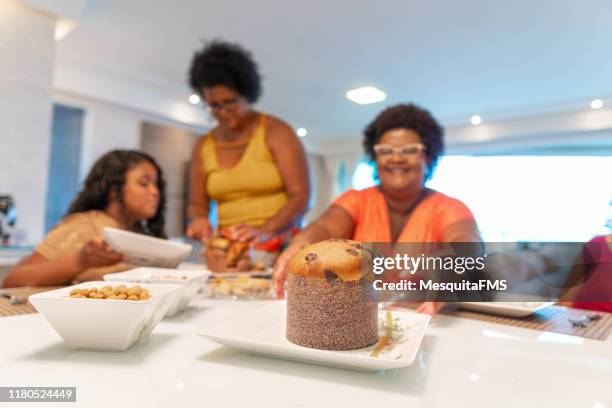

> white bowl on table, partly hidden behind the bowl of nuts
[104,268,210,316]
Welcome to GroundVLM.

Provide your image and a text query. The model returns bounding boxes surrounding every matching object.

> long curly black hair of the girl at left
[66,150,166,238]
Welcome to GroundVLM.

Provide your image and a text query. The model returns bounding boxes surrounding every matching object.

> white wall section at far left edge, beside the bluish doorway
[0,1,55,243]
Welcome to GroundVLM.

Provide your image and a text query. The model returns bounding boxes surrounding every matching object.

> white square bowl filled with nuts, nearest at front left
[29,281,180,350]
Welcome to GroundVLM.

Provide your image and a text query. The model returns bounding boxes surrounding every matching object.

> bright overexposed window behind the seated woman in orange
[353,156,612,241]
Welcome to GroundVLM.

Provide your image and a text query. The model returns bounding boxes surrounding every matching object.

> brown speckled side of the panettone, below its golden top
[287,274,378,350]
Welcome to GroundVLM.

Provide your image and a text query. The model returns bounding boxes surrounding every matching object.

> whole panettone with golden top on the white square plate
[287,239,378,350]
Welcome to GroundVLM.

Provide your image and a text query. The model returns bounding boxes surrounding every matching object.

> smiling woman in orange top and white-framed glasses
[274,104,481,313]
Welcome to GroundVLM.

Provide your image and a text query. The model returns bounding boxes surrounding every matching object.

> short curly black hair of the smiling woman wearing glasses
[363,103,444,176]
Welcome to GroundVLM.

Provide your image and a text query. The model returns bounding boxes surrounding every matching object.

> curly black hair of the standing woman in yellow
[189,40,261,103]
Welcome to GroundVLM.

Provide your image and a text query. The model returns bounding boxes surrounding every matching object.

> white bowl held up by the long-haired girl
[104,227,193,268]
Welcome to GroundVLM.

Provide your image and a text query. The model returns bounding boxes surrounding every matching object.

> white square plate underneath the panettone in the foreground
[198,301,430,371]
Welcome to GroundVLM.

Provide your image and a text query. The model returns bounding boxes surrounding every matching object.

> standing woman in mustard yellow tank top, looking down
[187,41,310,245]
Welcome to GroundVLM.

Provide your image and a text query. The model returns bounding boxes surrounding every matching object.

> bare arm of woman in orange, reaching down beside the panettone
[273,205,355,299]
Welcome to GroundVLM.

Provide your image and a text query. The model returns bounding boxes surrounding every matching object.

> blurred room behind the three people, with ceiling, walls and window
[0,0,612,256]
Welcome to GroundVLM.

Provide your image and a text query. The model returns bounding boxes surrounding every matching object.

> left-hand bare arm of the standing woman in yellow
[187,137,211,239]
